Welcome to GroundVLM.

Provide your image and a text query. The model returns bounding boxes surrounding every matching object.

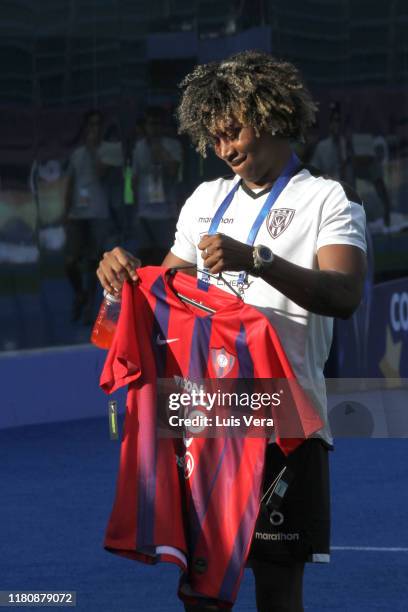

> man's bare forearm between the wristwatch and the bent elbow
[260,256,361,318]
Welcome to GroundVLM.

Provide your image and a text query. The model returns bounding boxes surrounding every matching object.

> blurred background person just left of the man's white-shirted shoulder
[132,107,182,265]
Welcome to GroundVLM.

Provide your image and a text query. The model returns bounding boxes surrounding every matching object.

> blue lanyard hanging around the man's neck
[200,152,300,287]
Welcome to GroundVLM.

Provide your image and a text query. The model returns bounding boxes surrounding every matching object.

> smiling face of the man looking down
[214,122,278,188]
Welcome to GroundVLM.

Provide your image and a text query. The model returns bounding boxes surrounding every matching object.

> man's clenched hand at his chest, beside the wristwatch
[198,234,254,274]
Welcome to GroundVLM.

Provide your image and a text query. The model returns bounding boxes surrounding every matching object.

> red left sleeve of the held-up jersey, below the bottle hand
[100,283,142,393]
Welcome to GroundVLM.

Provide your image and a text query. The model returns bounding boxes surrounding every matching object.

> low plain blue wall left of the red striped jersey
[0,344,125,429]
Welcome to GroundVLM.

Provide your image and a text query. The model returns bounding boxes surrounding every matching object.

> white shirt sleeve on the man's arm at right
[317,182,367,252]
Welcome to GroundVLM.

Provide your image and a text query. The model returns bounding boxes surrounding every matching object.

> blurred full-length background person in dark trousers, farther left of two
[65,110,118,325]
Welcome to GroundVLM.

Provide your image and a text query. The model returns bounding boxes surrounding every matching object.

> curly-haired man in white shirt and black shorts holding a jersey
[98,51,366,612]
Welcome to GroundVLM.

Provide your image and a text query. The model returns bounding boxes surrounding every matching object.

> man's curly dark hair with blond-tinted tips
[177,51,317,157]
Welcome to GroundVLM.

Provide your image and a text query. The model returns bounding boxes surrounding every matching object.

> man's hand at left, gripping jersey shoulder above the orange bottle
[96,247,142,293]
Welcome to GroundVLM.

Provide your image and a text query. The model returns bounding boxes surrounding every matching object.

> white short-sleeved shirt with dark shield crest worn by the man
[171,168,366,444]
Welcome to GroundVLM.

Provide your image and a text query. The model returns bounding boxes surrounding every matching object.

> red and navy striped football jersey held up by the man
[101,267,322,607]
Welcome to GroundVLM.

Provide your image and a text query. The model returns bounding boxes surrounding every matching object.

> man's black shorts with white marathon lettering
[249,438,330,564]
